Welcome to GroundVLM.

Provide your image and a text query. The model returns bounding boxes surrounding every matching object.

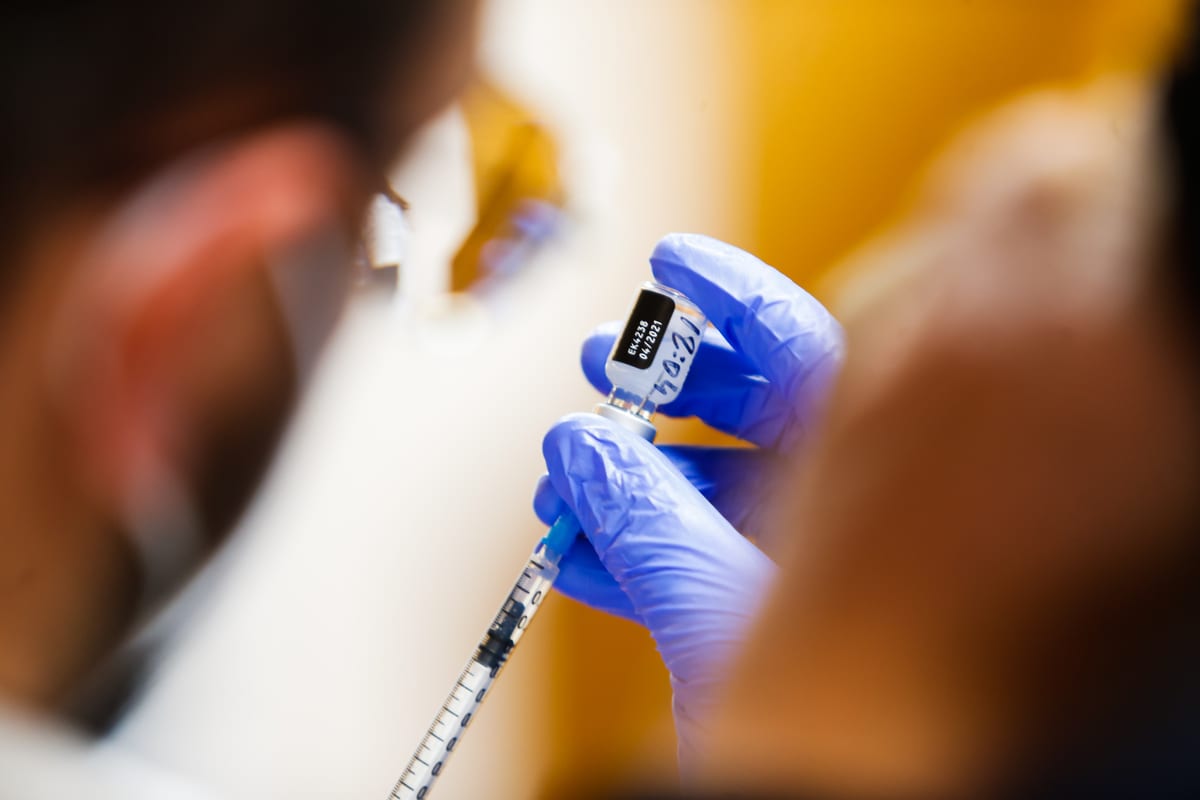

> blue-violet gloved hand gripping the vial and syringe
[534,235,842,760]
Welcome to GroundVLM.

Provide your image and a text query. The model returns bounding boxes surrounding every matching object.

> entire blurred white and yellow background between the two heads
[114,0,1182,800]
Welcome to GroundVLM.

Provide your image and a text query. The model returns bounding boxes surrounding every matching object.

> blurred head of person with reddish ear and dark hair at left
[0,0,475,703]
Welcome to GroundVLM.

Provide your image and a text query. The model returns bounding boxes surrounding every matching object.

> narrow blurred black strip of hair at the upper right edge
[1163,4,1200,333]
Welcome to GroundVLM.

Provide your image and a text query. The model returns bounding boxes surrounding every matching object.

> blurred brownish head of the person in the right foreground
[709,7,1200,796]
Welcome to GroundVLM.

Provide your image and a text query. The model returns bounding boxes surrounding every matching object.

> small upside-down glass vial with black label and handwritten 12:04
[596,281,708,440]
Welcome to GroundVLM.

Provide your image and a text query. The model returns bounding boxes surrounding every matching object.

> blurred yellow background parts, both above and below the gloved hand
[530,0,1181,796]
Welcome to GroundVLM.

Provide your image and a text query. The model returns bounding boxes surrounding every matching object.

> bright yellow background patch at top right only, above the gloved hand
[744,0,1178,282]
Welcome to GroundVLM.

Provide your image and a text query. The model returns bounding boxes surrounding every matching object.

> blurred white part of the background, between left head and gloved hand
[116,0,744,800]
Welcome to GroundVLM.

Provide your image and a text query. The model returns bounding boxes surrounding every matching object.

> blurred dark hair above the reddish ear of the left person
[0,0,450,273]
